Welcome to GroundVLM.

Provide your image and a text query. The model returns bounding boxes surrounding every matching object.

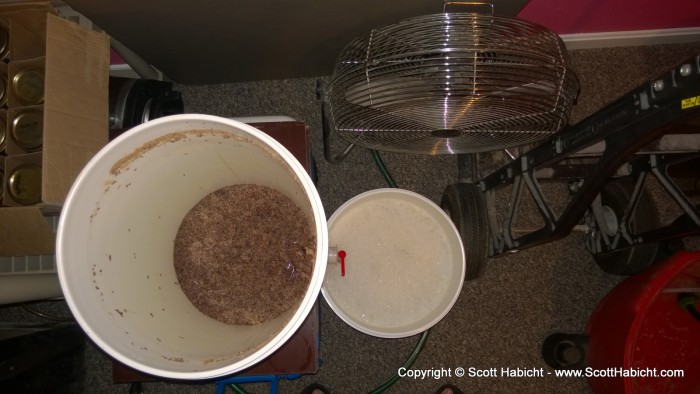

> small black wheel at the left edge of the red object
[542,333,588,369]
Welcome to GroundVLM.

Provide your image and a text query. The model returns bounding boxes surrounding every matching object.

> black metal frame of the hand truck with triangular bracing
[479,55,700,256]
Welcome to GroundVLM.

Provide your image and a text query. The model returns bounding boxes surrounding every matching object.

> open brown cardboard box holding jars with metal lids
[0,6,110,256]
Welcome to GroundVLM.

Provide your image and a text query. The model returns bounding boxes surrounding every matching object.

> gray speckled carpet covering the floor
[4,43,700,393]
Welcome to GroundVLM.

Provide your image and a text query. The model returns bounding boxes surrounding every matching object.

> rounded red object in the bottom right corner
[587,252,700,394]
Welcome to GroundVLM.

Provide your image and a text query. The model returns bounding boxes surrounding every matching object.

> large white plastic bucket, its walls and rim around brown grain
[56,115,328,380]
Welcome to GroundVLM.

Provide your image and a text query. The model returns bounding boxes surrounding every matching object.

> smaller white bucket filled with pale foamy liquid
[321,189,465,338]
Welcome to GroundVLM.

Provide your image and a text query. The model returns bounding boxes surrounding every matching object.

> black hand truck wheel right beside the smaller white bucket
[440,183,489,280]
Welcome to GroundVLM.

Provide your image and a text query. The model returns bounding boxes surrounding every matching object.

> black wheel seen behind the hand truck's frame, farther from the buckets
[593,180,659,275]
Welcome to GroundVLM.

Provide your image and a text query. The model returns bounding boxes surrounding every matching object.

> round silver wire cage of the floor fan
[326,13,578,154]
